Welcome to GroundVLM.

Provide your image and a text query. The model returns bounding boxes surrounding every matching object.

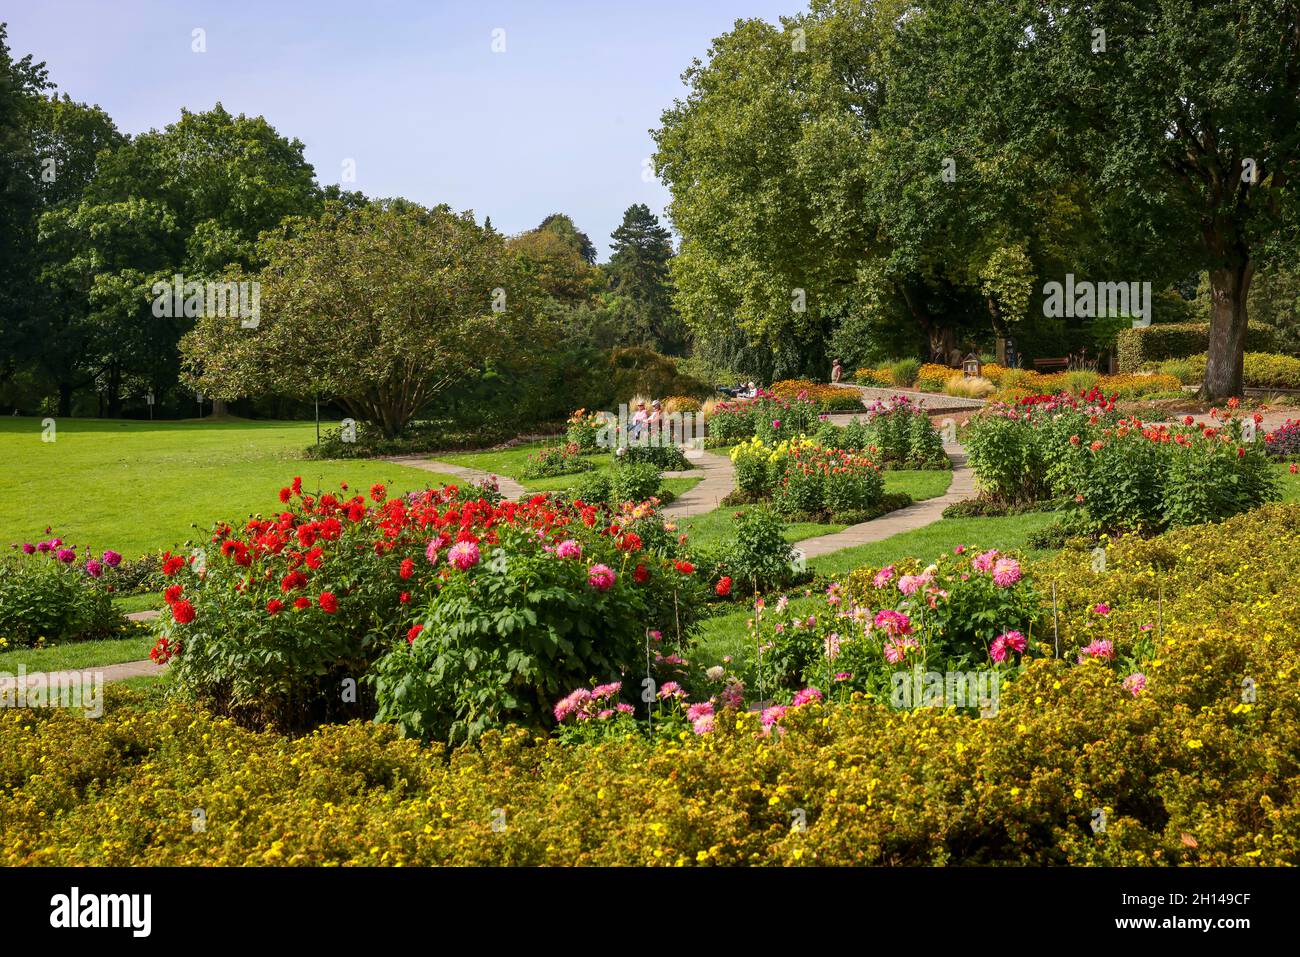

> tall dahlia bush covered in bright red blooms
[152,478,691,727]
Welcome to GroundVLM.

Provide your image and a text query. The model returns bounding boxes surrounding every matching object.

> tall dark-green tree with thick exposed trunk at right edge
[901,0,1300,398]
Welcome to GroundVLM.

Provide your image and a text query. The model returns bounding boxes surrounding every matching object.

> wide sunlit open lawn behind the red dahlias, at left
[0,417,456,558]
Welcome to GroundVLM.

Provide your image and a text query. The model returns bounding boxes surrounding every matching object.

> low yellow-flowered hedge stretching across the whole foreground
[0,505,1300,866]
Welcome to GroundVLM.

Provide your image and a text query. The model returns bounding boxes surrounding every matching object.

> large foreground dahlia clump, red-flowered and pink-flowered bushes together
[153,480,696,736]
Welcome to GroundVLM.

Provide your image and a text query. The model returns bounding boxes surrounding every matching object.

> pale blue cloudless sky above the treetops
[0,0,805,259]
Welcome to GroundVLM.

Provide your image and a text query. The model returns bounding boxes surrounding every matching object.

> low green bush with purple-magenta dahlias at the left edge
[0,538,126,648]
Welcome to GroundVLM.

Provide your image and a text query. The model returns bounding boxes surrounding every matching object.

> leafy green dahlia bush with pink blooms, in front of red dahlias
[372,528,650,741]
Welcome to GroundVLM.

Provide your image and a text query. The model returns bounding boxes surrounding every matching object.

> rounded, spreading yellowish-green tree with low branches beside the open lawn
[182,202,537,436]
